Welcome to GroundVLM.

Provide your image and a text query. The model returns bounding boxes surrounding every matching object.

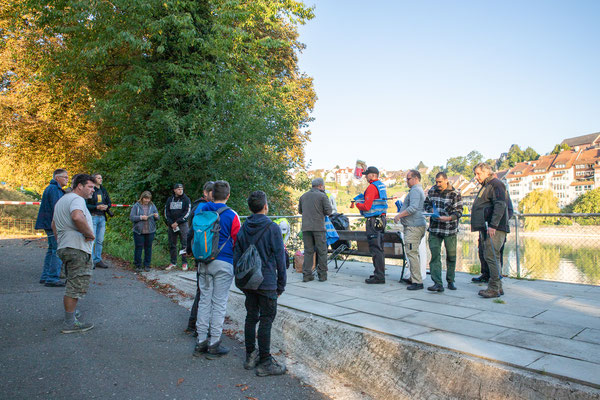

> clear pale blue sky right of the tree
[299,0,600,170]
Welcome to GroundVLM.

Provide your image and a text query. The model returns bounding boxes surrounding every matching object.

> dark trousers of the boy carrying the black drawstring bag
[244,290,277,360]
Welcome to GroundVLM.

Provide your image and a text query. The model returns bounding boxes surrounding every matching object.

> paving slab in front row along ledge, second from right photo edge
[411,331,544,367]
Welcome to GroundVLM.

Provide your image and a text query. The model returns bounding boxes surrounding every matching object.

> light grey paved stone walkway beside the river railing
[158,262,600,388]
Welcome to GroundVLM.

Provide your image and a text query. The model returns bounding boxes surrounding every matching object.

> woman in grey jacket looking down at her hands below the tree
[129,190,159,272]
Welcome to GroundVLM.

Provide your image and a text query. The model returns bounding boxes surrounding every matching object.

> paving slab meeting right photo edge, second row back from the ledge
[492,329,600,363]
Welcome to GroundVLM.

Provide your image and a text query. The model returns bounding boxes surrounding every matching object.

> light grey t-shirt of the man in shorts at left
[54,193,94,254]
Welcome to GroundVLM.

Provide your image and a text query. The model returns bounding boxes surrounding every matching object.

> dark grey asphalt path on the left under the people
[0,239,328,400]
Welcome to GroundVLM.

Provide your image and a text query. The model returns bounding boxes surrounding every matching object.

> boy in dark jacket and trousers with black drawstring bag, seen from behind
[233,191,286,376]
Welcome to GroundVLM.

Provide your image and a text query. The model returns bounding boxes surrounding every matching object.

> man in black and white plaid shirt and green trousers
[423,172,462,292]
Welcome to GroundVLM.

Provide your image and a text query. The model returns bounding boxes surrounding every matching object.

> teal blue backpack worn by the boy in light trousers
[192,207,230,264]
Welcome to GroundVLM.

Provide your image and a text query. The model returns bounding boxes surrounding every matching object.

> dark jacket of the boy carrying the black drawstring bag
[233,214,287,294]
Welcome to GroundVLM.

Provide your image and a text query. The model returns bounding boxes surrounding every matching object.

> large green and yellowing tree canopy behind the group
[1,0,316,211]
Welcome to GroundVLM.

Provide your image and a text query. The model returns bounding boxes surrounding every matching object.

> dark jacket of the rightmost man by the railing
[471,176,512,233]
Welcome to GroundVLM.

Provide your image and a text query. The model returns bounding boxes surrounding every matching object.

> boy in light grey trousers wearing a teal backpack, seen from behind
[192,181,240,360]
